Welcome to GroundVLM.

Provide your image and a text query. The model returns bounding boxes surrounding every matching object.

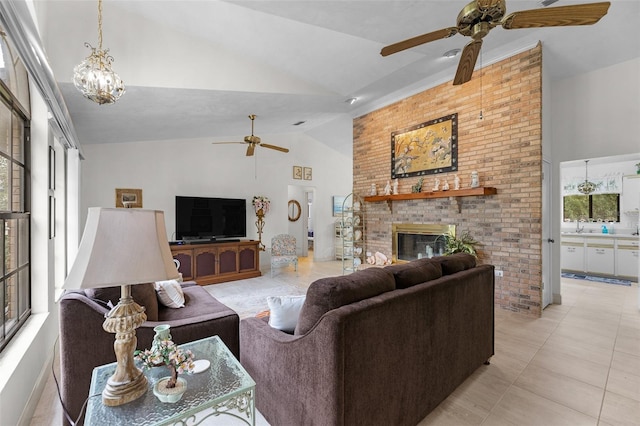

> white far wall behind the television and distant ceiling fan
[81,130,352,265]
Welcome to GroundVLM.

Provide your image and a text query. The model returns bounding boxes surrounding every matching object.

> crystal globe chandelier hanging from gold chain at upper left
[73,0,125,105]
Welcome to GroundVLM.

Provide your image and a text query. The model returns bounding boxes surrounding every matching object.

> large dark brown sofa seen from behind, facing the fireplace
[240,254,494,426]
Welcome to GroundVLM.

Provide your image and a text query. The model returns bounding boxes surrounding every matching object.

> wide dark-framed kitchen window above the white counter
[563,194,620,222]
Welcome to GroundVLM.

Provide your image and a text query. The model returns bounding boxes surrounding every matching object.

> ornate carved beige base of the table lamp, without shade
[102,285,148,407]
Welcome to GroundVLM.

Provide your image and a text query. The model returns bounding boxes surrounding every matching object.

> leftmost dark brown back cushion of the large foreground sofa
[295,268,396,335]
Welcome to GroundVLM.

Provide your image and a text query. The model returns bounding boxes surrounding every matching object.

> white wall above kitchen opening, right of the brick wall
[544,58,640,303]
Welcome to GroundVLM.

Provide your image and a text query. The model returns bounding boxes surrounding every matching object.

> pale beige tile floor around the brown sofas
[31,260,640,426]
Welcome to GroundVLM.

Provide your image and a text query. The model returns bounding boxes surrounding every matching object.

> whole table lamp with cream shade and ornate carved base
[63,207,179,406]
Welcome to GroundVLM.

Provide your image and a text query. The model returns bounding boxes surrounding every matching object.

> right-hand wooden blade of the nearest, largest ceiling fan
[501,1,611,30]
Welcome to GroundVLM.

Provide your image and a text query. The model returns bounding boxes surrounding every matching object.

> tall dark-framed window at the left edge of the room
[0,36,31,349]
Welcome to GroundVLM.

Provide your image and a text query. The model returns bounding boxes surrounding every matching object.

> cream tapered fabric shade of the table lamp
[64,207,179,289]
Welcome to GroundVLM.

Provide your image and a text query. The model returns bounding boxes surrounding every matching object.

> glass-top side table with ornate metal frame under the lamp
[84,336,256,426]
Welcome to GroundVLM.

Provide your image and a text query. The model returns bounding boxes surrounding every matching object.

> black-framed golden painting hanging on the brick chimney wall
[391,113,458,179]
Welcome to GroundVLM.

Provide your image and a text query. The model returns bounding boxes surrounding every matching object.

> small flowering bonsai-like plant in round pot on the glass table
[135,339,195,402]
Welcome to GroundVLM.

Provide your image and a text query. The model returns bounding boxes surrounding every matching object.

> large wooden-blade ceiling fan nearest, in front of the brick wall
[380,0,611,85]
